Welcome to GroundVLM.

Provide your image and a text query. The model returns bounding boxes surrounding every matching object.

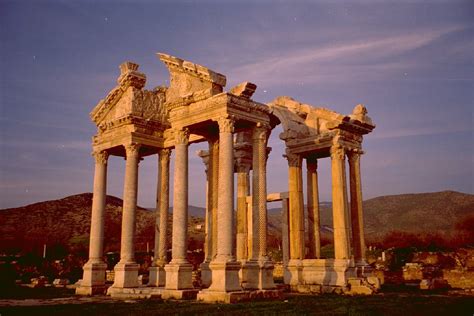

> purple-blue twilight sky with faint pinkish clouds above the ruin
[0,0,474,208]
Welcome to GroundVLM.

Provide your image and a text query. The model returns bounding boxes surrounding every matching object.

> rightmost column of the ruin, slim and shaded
[348,150,366,265]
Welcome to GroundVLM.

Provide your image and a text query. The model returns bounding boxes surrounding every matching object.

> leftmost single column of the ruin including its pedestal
[76,151,109,295]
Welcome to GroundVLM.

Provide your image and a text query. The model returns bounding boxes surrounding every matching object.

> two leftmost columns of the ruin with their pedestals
[76,143,140,295]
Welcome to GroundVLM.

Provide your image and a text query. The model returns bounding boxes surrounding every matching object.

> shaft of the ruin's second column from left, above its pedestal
[120,143,140,263]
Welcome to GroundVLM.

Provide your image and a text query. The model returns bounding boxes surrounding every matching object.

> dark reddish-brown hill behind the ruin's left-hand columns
[0,193,203,251]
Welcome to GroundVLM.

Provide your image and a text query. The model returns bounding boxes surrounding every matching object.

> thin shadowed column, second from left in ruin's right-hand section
[306,156,321,259]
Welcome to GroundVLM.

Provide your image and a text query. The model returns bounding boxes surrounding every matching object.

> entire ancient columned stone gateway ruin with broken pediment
[76,54,377,302]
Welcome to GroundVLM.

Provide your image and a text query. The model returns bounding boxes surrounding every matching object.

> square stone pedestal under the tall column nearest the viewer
[209,261,242,292]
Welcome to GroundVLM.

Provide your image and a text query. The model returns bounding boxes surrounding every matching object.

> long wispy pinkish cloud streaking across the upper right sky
[226,26,462,85]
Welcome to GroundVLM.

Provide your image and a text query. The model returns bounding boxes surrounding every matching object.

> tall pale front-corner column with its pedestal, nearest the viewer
[208,118,241,293]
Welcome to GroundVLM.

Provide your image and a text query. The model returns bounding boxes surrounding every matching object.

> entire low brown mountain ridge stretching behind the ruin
[0,191,474,251]
